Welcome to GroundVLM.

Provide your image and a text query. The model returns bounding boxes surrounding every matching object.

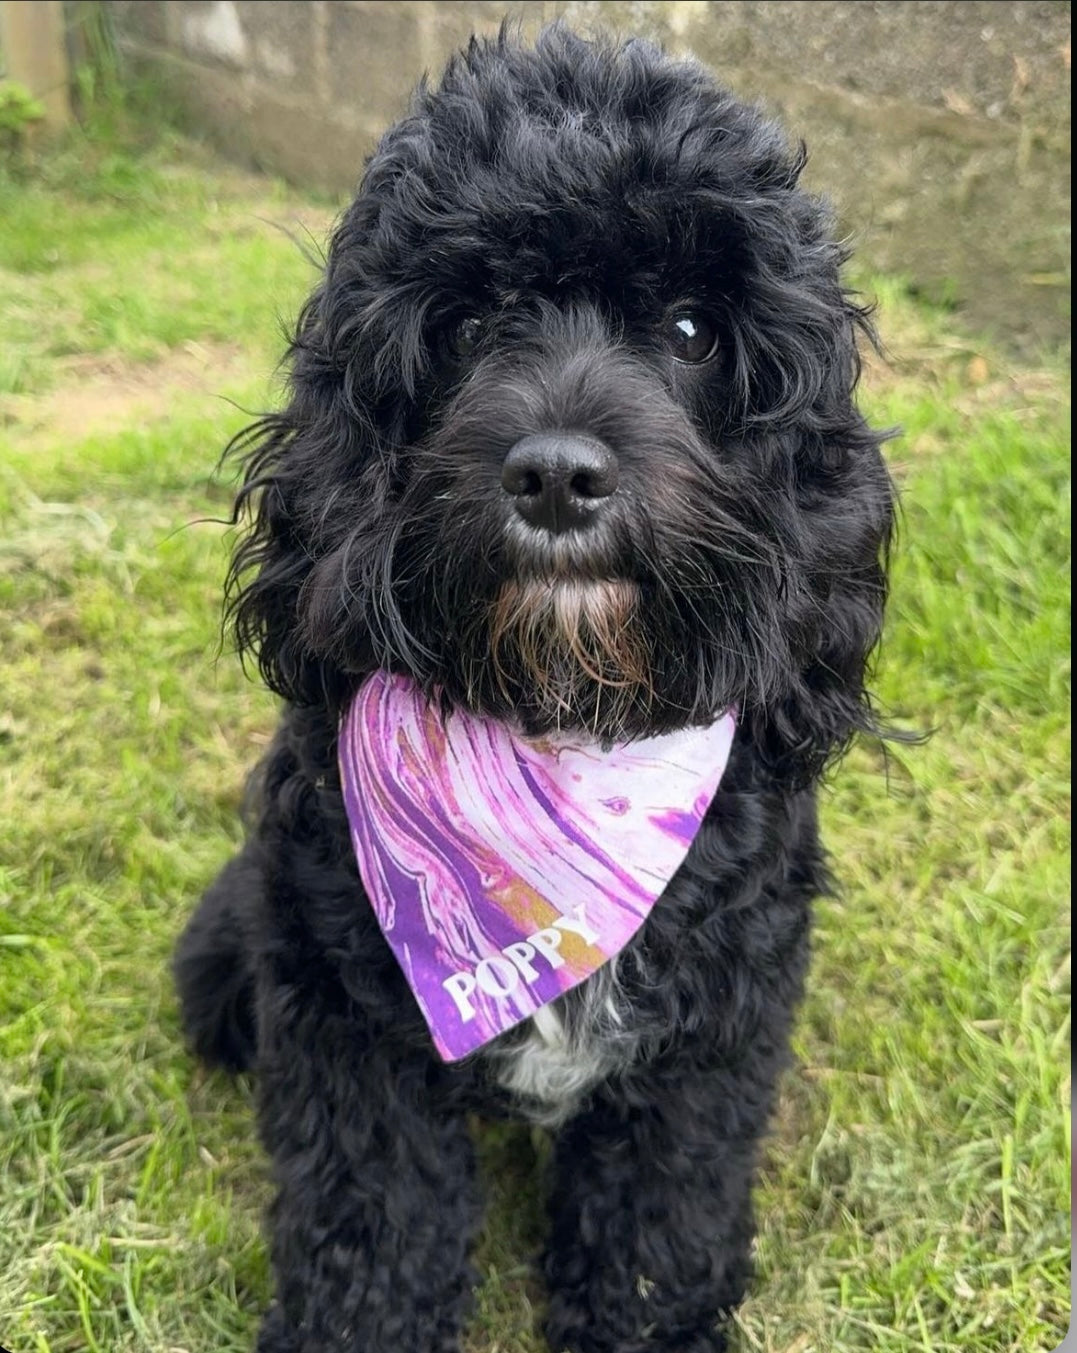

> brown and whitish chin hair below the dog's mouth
[488,579,655,736]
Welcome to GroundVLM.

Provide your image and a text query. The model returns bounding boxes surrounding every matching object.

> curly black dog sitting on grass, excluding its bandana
[176,27,893,1353]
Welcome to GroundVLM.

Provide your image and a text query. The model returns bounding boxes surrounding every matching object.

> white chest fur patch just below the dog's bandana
[488,959,639,1127]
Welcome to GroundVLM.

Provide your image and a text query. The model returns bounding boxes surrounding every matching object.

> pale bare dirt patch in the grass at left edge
[0,342,264,441]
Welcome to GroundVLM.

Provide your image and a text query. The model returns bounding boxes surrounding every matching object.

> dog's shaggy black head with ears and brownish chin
[231,26,893,778]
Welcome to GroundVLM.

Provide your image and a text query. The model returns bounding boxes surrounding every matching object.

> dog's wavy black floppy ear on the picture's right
[747,288,896,783]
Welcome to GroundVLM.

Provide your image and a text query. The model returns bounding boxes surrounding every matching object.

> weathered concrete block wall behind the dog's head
[108,0,1070,346]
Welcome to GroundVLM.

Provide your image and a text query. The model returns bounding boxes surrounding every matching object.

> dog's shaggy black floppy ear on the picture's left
[226,150,449,709]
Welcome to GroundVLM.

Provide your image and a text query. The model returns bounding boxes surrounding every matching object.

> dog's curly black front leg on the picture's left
[257,1011,479,1353]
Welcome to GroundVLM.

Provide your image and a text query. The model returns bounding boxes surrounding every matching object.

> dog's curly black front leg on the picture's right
[547,1068,770,1353]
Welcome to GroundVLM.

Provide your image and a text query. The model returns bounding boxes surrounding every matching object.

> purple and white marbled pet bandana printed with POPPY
[340,672,733,1062]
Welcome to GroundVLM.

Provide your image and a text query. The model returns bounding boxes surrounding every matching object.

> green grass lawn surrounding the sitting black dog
[0,121,1069,1353]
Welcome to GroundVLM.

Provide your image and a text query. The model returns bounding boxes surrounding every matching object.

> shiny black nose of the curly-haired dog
[501,432,618,534]
